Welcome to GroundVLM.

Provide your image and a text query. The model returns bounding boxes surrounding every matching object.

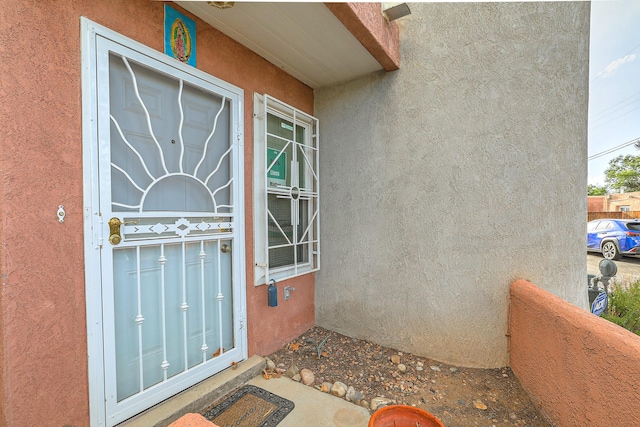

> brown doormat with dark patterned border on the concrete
[202,385,294,427]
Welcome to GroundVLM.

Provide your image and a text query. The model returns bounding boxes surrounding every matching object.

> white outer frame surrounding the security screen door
[81,17,247,426]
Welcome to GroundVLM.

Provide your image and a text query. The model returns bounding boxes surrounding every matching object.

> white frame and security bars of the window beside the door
[253,93,320,286]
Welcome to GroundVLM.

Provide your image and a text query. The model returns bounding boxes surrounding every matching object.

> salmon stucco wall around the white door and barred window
[0,0,314,426]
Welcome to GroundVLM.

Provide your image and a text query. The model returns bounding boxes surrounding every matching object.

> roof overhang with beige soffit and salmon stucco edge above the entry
[174,1,399,89]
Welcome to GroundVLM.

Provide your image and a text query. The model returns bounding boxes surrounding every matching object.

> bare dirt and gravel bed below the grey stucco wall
[269,327,550,427]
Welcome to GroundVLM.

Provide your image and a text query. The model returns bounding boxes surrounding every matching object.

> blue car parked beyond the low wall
[587,219,640,259]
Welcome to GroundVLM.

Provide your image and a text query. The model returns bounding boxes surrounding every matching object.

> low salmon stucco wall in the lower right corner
[509,280,640,427]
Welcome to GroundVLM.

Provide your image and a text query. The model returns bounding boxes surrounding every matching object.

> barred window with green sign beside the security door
[254,94,320,285]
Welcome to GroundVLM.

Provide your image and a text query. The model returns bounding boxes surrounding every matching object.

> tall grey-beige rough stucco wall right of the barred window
[315,2,590,367]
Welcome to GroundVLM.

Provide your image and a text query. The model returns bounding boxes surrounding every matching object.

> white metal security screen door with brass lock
[82,20,246,426]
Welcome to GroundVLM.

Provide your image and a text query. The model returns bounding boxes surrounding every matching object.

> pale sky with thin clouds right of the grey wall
[588,0,640,185]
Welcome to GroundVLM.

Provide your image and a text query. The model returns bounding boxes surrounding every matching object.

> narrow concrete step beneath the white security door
[118,356,265,427]
